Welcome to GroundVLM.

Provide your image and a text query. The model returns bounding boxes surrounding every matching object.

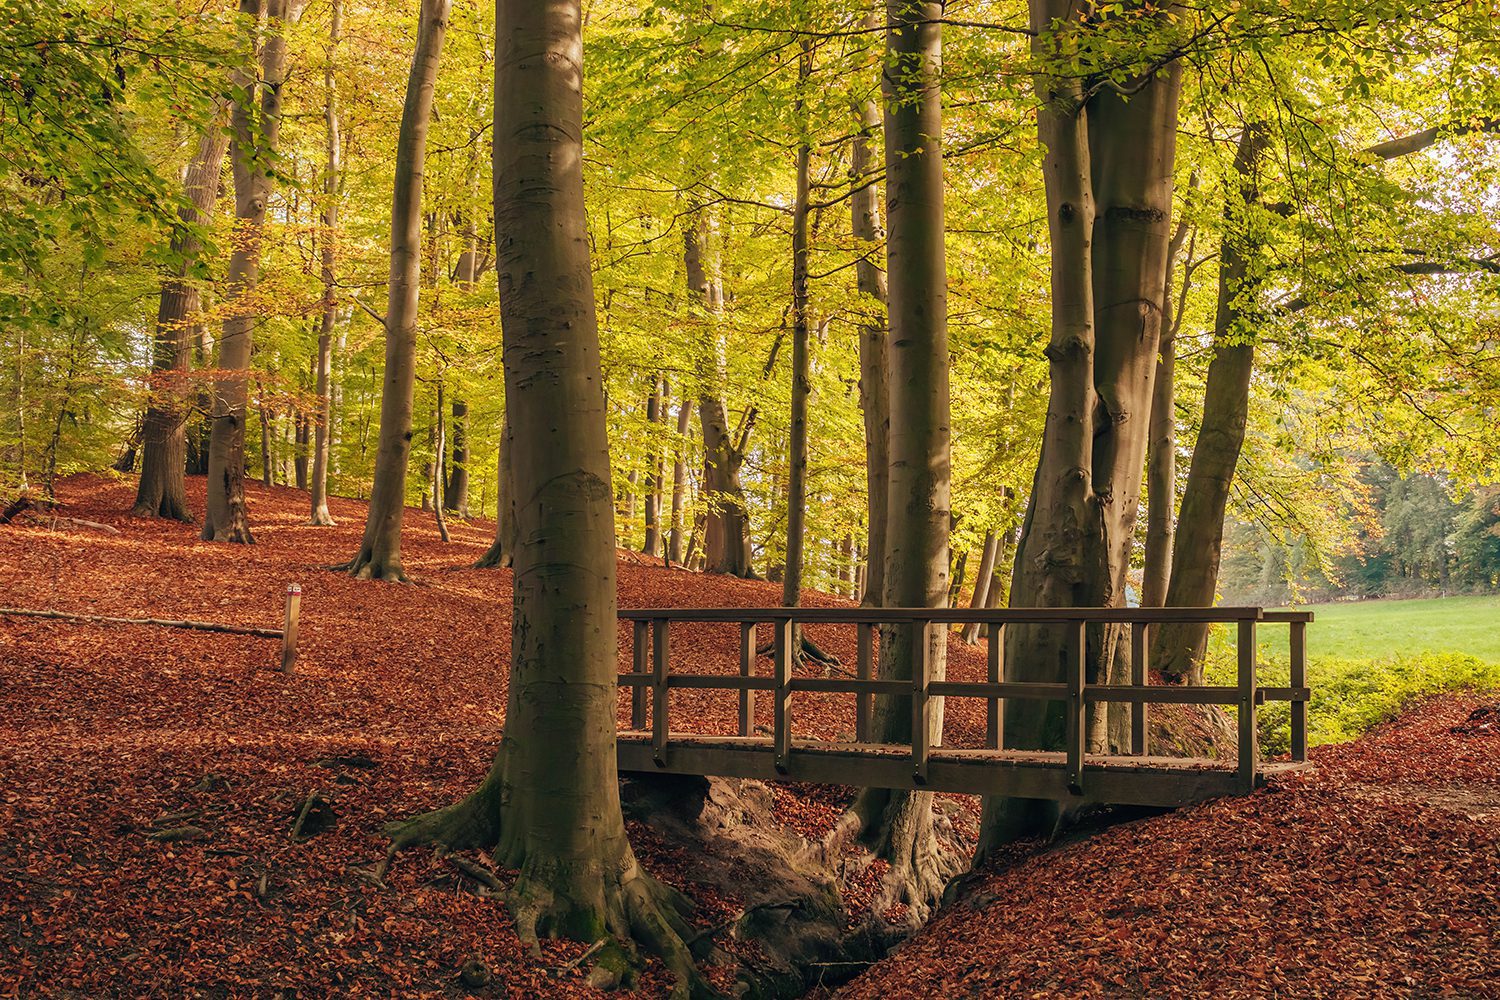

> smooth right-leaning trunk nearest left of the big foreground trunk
[347,0,450,580]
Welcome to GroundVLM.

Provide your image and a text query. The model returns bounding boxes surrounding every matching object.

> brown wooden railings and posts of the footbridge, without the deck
[620,607,1313,795]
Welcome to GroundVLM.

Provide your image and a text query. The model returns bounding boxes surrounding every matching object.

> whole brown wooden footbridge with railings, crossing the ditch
[620,607,1313,807]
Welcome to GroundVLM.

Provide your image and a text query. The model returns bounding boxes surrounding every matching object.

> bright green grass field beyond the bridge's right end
[1260,595,1500,663]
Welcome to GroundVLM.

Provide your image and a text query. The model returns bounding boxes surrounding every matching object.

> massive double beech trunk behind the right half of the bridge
[978,0,1181,859]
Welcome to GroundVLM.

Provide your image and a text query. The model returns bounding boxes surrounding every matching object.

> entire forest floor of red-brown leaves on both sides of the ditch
[0,477,1500,997]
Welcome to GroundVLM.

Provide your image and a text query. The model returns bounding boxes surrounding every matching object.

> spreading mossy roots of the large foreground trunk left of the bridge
[375,780,722,1000]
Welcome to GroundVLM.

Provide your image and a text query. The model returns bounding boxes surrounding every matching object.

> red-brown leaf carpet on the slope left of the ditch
[0,477,984,997]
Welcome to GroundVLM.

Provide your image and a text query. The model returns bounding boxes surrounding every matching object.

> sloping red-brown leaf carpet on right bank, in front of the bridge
[839,693,1500,1000]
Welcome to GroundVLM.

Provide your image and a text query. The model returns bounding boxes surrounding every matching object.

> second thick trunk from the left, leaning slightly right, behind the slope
[203,0,306,544]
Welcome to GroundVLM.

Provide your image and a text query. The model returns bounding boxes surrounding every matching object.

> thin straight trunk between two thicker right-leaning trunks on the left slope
[309,0,344,526]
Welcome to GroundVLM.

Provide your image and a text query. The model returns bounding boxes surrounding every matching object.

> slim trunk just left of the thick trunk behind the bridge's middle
[849,48,891,606]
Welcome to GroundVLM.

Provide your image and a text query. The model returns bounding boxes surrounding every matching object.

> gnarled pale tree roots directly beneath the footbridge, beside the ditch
[824,789,968,930]
